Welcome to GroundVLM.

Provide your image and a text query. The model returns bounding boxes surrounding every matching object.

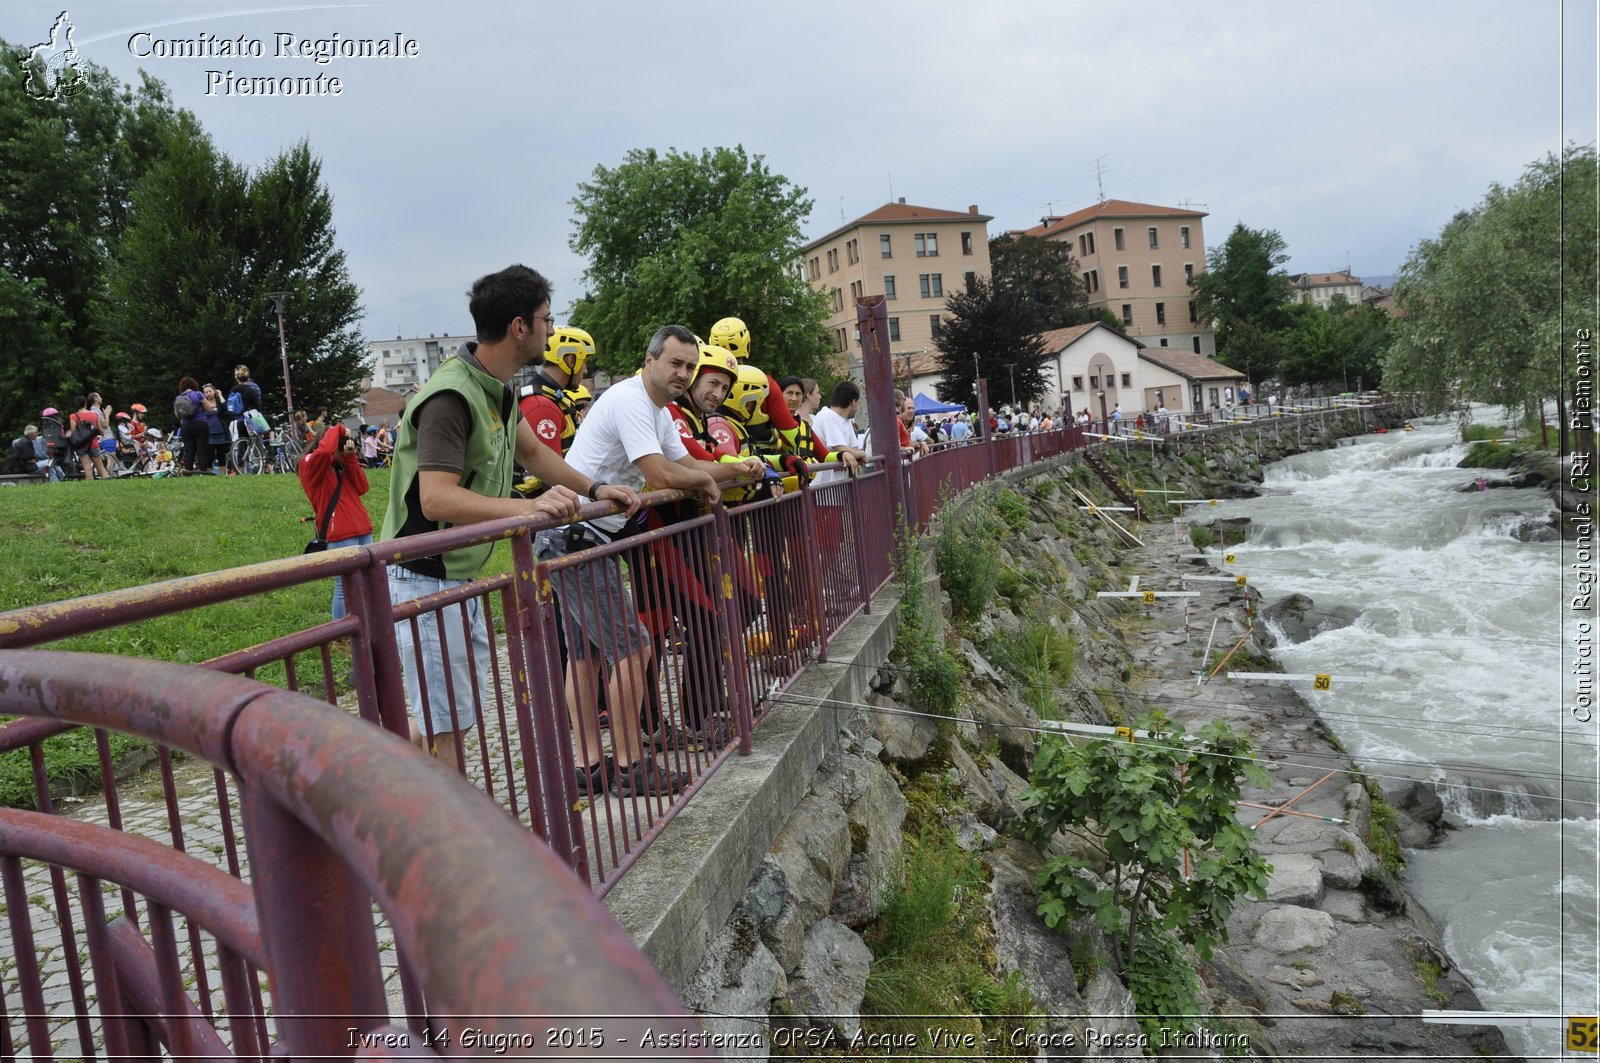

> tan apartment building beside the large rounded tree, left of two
[800,197,992,367]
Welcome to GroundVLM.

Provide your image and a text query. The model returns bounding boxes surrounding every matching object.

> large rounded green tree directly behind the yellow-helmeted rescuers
[570,146,832,376]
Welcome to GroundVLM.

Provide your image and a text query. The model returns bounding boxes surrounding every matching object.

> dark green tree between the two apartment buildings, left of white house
[938,277,1050,410]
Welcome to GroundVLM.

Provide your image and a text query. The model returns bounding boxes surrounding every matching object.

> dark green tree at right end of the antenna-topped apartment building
[1189,223,1291,381]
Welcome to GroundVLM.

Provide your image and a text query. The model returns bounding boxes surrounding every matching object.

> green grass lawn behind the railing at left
[0,469,510,807]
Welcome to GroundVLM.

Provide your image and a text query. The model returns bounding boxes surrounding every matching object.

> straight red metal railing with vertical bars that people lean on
[0,422,1113,1055]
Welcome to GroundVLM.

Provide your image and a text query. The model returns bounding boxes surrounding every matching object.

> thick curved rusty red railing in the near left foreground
[0,650,707,1058]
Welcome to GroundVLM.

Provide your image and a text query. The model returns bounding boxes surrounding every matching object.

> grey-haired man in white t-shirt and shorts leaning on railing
[534,325,722,796]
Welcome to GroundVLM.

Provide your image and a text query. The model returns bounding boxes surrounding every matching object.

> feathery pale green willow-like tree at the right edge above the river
[1386,144,1600,450]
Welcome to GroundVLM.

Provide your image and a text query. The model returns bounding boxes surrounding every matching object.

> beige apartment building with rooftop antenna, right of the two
[1021,199,1216,357]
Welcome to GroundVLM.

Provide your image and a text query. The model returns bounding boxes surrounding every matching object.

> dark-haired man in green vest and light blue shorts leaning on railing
[381,266,638,767]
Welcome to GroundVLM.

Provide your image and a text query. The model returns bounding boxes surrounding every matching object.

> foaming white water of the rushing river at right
[1206,411,1600,1058]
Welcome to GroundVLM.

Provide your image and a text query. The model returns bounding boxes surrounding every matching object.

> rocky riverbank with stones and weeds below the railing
[668,406,1506,1060]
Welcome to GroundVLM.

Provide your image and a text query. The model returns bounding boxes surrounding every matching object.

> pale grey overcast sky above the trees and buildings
[0,0,1597,338]
